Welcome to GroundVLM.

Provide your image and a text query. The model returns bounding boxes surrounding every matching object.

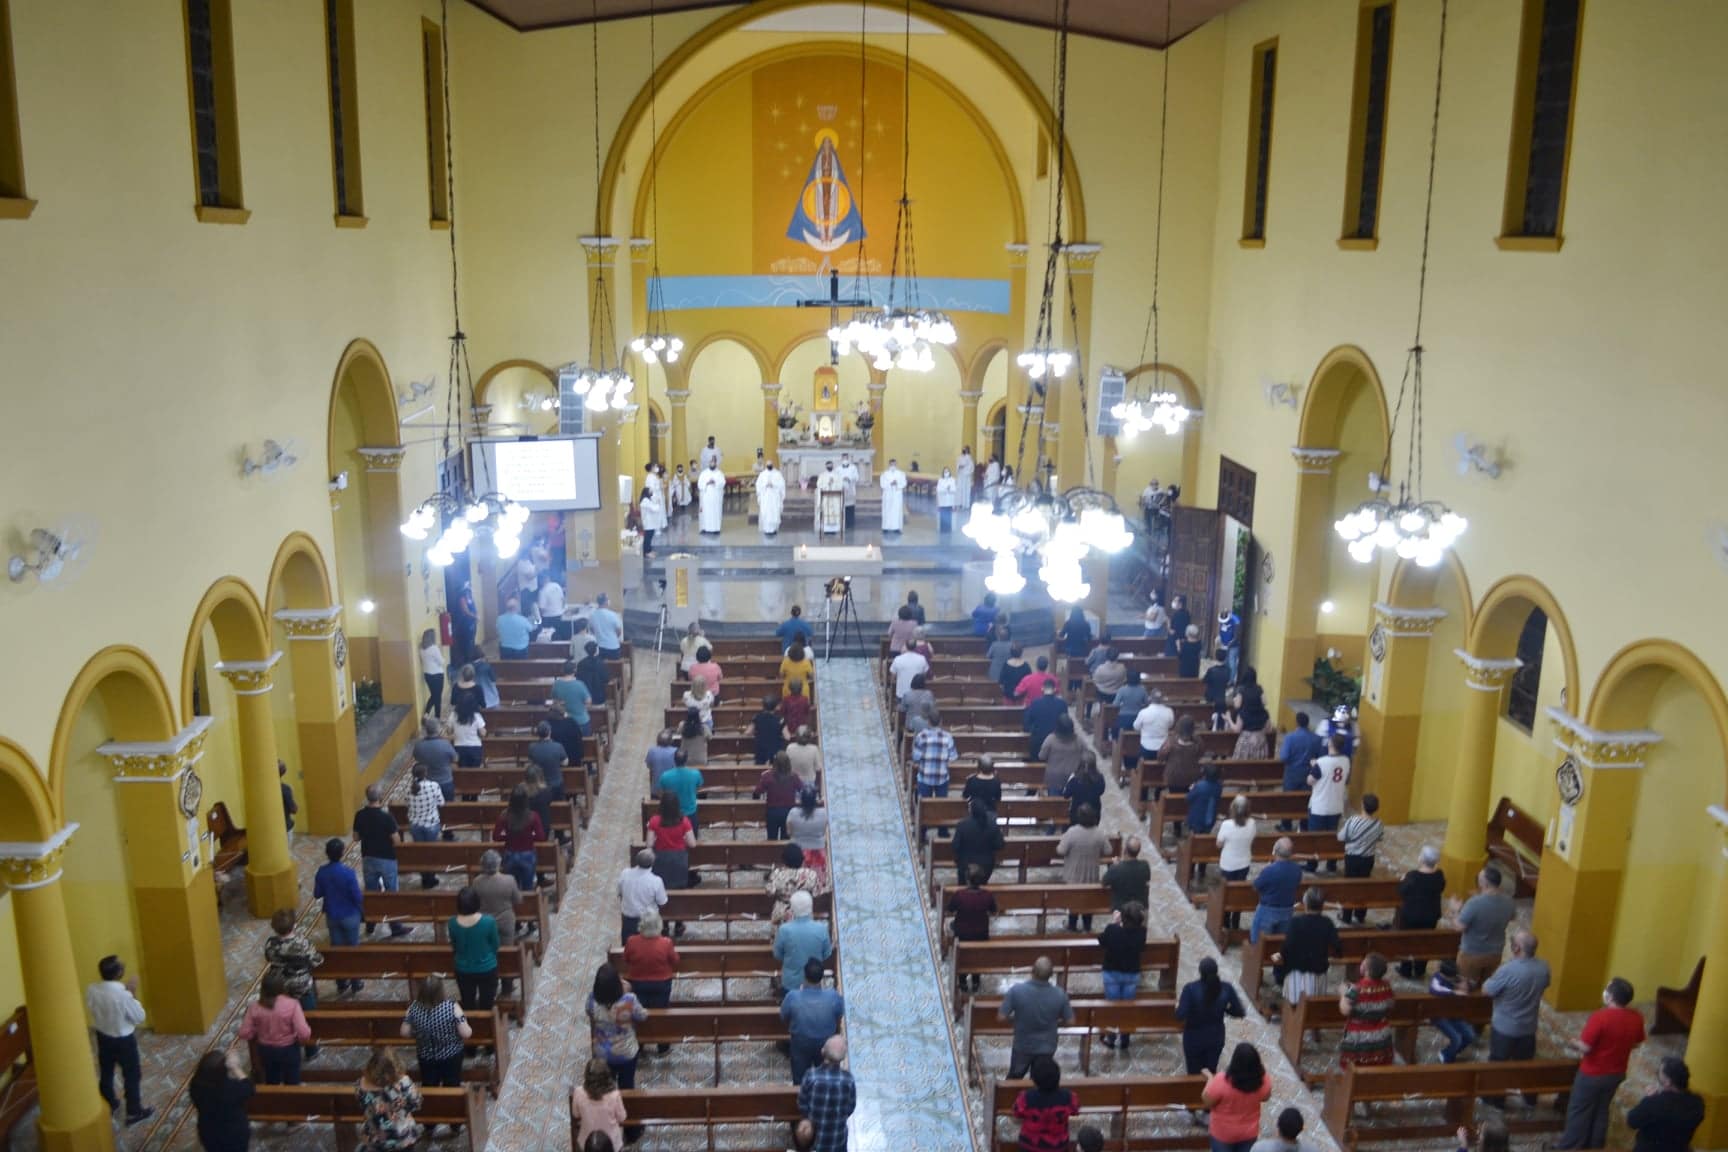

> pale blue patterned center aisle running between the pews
[816,660,975,1152]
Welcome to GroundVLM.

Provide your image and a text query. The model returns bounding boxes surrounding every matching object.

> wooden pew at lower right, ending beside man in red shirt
[1320,1060,1578,1149]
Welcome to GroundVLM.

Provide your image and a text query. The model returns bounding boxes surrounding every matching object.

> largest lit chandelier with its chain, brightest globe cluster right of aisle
[961,0,1134,603]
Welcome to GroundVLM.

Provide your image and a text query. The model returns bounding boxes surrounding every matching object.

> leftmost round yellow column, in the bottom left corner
[0,824,114,1152]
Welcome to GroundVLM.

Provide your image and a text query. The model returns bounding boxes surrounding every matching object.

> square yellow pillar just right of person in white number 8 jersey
[1350,604,1446,824]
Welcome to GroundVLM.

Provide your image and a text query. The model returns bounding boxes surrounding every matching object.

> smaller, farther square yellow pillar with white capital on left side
[276,604,359,836]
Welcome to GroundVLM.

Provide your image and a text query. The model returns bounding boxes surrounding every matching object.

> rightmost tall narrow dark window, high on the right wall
[1502,0,1585,250]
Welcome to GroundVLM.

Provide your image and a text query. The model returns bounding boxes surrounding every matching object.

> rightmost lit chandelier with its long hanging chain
[1332,0,1469,568]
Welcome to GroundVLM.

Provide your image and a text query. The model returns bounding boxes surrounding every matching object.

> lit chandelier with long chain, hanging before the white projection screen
[401,0,529,568]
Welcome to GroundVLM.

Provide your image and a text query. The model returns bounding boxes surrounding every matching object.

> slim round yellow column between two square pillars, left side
[216,653,301,919]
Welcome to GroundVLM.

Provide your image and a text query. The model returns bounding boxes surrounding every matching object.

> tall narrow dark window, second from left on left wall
[185,0,249,225]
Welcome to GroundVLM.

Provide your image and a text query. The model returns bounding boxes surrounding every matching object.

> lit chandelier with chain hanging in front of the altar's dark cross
[828,0,959,371]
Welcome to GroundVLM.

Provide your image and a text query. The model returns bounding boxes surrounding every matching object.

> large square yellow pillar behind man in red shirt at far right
[1531,708,1665,1008]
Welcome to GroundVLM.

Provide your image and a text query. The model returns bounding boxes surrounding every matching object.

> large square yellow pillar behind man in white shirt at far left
[98,717,226,1036]
